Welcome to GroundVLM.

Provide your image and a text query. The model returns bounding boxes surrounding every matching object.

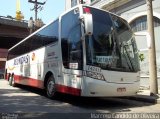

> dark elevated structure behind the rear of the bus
[0,16,29,74]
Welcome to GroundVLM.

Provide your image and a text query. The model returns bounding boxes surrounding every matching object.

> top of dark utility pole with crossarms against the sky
[28,0,46,21]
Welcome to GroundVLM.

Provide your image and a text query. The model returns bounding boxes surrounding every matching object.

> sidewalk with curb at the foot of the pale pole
[130,88,160,104]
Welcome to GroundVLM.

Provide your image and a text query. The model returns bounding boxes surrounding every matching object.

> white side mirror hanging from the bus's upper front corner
[80,14,93,35]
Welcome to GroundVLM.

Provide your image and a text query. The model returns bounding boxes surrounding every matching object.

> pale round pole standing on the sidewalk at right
[146,0,158,96]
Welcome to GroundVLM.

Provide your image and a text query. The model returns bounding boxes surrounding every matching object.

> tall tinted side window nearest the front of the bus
[61,9,82,69]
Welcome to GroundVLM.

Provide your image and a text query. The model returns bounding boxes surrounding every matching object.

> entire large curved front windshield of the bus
[85,8,140,72]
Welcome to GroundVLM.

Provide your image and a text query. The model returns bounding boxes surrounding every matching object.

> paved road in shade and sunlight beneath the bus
[0,79,160,118]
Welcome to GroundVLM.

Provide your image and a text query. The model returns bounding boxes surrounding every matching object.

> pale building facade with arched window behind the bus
[66,0,160,78]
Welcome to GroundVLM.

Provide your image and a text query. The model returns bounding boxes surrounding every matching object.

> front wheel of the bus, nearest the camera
[46,75,56,99]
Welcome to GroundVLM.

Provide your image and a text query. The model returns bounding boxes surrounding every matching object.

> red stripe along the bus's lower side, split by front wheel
[14,75,81,96]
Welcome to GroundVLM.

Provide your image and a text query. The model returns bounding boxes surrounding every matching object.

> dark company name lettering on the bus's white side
[14,55,29,65]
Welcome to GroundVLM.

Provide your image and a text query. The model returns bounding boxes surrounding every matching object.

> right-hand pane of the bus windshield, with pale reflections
[112,15,140,71]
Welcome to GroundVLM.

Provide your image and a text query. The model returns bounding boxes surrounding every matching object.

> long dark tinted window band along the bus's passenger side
[8,20,58,59]
